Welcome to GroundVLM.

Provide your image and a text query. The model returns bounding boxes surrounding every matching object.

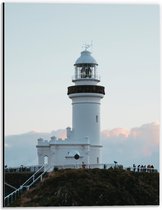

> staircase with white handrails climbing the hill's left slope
[4,165,50,206]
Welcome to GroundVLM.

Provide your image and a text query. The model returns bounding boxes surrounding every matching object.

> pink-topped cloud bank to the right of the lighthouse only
[102,123,160,168]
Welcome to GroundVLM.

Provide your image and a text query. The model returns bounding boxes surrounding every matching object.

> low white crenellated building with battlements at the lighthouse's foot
[36,131,102,167]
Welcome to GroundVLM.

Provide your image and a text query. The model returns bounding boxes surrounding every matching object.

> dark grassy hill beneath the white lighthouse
[12,169,159,207]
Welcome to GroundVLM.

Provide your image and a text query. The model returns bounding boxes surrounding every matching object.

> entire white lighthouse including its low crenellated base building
[36,49,105,167]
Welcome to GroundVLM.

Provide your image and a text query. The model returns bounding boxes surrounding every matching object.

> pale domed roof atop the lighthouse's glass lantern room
[74,50,98,66]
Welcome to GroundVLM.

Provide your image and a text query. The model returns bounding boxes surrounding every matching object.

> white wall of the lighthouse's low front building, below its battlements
[37,141,102,166]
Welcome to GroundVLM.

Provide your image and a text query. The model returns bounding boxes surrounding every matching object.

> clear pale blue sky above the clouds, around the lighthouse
[5,3,160,134]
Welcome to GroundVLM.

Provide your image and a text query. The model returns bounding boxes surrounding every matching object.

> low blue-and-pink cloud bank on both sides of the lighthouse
[5,123,160,169]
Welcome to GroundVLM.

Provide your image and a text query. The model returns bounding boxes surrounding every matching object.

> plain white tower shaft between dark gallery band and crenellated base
[69,93,103,145]
